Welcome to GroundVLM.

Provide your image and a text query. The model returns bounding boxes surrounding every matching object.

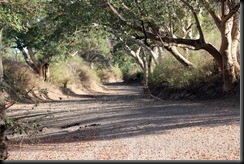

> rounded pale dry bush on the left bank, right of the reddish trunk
[49,56,105,92]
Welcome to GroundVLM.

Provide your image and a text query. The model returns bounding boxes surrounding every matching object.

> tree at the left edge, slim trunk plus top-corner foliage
[0,0,37,160]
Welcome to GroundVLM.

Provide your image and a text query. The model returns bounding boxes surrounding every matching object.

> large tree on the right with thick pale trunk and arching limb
[94,0,240,92]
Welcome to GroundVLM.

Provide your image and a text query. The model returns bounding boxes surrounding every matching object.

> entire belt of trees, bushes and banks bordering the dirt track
[0,0,240,159]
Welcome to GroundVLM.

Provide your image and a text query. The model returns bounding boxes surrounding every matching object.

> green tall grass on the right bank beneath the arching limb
[149,51,214,88]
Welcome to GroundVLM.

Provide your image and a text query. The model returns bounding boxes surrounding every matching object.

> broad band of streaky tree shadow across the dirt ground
[6,84,240,143]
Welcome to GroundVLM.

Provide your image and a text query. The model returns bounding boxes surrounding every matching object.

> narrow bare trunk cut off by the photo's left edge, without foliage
[0,29,8,160]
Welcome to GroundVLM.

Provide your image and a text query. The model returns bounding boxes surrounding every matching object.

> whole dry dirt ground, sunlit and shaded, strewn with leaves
[7,83,241,161]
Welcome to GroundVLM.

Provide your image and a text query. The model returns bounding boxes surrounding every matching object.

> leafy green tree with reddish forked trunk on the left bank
[3,1,109,80]
